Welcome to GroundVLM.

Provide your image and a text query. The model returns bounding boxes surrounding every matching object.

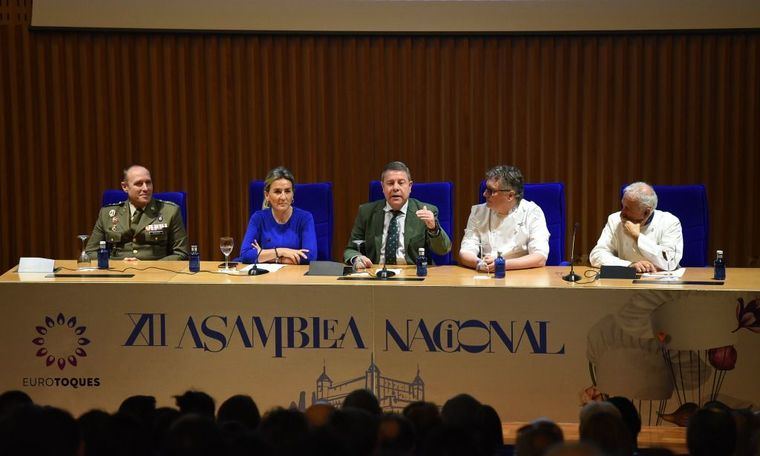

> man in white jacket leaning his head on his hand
[589,182,683,272]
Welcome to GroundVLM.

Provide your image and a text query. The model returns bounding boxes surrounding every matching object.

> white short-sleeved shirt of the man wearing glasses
[459,200,549,259]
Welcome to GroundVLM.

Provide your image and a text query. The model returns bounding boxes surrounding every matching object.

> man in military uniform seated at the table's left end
[86,165,188,260]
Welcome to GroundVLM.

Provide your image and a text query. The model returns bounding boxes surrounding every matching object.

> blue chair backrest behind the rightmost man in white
[620,184,710,267]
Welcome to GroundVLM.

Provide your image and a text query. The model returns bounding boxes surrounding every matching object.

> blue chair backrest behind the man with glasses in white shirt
[478,181,567,266]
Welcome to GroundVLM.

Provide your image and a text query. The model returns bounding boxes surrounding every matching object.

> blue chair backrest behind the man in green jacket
[369,181,454,265]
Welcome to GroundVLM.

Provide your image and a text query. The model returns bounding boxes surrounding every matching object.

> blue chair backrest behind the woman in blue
[248,180,333,261]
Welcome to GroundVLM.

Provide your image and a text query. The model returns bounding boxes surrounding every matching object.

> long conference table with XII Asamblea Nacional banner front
[0,260,760,424]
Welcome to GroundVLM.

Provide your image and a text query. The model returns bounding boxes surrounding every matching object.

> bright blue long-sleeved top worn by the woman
[238,207,317,264]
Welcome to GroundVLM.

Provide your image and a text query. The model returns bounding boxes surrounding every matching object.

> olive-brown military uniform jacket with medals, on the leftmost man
[86,199,188,260]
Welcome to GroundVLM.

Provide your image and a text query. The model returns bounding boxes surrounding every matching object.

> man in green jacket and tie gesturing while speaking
[343,161,451,267]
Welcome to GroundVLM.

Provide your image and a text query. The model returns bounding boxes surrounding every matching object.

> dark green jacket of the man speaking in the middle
[343,198,451,264]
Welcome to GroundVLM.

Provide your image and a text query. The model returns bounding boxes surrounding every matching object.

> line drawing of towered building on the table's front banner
[291,355,425,412]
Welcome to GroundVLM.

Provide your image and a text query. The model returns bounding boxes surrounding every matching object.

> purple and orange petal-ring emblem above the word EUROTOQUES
[32,313,90,370]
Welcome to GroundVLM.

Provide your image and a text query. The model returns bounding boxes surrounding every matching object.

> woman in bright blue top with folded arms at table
[240,166,317,264]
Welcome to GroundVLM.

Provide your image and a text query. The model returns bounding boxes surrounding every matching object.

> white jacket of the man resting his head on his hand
[589,210,683,271]
